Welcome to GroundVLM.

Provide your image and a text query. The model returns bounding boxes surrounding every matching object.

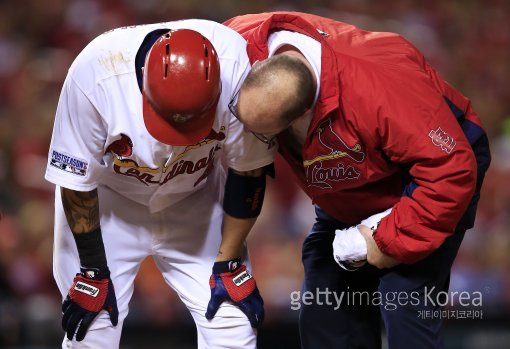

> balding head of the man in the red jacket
[238,53,315,134]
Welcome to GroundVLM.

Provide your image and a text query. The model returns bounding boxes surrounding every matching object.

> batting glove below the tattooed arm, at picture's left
[62,268,119,341]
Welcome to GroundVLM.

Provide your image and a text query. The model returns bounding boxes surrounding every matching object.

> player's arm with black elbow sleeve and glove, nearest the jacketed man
[205,168,266,328]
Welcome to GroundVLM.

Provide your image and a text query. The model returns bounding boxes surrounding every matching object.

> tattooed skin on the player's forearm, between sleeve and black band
[61,188,99,234]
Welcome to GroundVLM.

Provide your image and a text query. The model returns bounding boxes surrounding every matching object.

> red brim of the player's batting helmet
[142,93,219,146]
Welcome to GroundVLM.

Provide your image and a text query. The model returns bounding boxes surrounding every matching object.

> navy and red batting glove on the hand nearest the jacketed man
[205,258,264,328]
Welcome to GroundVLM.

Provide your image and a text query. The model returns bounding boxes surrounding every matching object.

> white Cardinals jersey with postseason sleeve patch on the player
[45,19,276,212]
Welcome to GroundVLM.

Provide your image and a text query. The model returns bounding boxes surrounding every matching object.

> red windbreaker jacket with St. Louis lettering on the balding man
[225,12,490,263]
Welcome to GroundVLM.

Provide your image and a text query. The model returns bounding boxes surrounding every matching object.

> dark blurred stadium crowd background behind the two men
[0,0,510,349]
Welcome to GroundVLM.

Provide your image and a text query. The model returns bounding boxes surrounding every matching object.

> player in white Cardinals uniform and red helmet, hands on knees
[46,20,274,348]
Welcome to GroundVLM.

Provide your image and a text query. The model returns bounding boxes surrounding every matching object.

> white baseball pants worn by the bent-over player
[53,187,256,349]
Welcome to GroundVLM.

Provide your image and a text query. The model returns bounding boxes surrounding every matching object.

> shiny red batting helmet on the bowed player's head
[142,29,221,145]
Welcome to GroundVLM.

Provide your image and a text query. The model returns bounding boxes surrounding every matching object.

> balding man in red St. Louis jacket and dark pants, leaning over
[225,12,490,349]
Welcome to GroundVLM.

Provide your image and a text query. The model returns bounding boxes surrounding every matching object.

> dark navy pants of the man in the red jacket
[299,208,464,349]
